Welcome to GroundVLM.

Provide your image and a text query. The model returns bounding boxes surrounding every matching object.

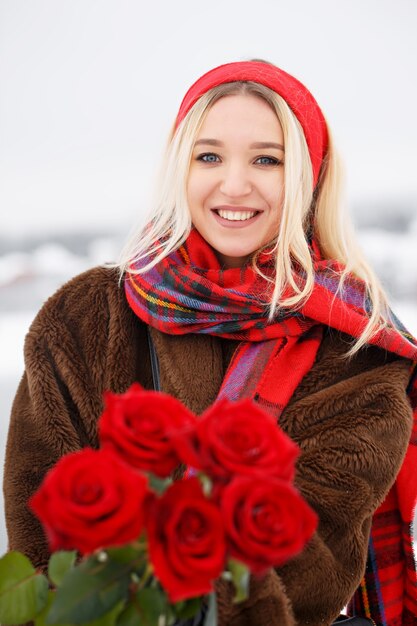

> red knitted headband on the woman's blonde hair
[175,61,328,186]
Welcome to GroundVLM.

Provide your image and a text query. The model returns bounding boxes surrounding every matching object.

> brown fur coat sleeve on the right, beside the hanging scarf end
[277,360,412,626]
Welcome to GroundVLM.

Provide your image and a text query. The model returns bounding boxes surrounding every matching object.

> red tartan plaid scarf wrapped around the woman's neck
[125,230,417,626]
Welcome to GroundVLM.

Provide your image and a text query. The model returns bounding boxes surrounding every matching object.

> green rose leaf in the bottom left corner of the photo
[0,552,48,625]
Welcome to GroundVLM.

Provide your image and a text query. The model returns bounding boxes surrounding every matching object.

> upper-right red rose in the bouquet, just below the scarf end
[177,399,298,481]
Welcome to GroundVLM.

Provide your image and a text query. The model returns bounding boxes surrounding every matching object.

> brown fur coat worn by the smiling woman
[4,268,411,626]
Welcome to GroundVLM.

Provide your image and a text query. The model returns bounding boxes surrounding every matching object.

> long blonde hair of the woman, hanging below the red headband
[118,81,388,355]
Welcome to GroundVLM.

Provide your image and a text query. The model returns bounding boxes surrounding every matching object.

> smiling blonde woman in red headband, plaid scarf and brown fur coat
[4,61,417,626]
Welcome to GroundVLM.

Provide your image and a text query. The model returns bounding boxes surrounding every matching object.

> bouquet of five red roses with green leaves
[0,384,317,626]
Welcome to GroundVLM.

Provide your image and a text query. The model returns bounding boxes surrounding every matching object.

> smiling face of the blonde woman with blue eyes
[187,95,284,268]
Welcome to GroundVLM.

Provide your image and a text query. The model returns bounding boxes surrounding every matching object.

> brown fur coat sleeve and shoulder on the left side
[3,268,148,567]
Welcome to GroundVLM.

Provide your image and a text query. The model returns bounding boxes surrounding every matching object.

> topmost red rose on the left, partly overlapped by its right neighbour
[99,384,196,477]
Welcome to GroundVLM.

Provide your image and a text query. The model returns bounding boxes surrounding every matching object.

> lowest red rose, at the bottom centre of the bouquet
[146,478,226,602]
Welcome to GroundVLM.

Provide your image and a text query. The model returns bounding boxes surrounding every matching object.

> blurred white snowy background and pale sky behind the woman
[0,0,417,554]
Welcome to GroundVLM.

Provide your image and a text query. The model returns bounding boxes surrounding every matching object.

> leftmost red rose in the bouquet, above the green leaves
[29,448,149,554]
